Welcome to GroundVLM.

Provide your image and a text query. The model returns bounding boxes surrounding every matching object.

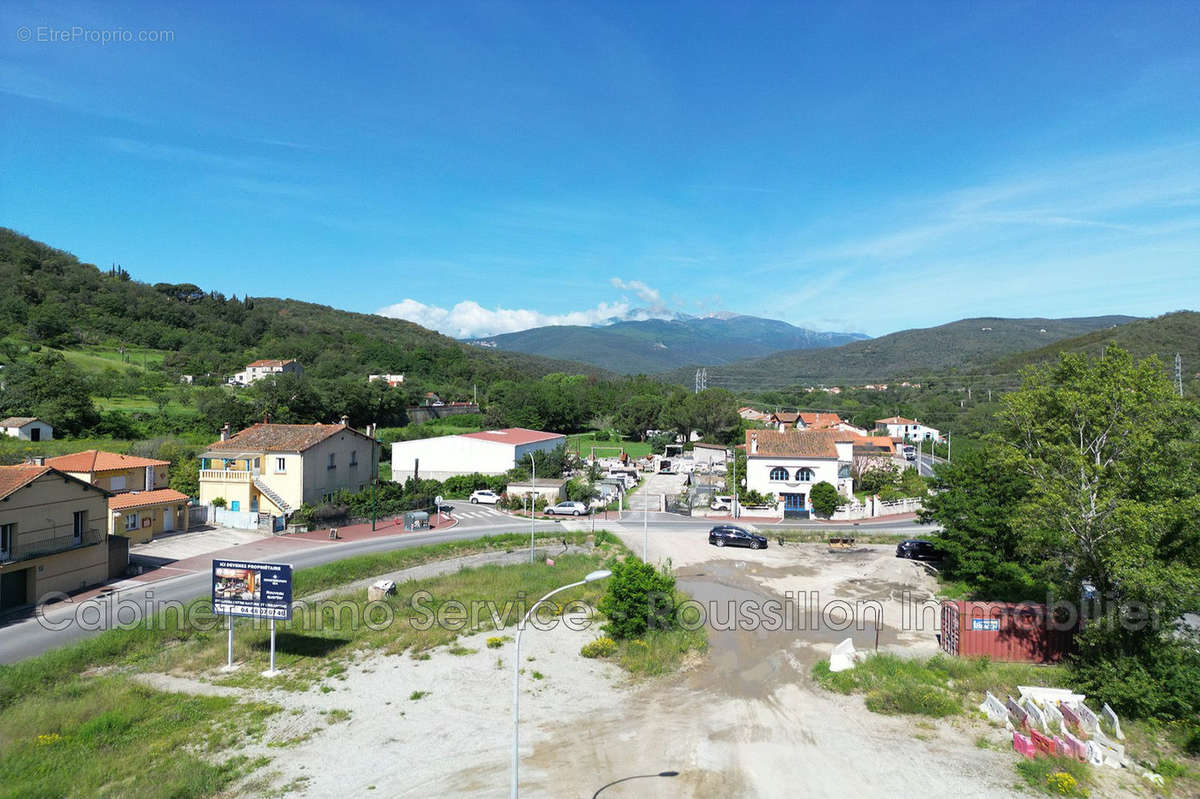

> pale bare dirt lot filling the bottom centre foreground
[166,525,1041,799]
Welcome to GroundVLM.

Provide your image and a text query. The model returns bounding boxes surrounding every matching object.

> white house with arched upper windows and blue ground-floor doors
[745,429,854,518]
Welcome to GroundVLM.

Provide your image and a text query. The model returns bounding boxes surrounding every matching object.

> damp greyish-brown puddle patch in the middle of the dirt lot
[676,561,898,699]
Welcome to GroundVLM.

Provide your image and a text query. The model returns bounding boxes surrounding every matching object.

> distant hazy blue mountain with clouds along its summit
[463,316,865,374]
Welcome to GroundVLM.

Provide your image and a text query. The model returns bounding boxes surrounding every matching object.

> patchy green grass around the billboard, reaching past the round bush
[0,533,704,799]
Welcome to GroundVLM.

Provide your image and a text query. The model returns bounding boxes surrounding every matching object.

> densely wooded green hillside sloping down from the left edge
[0,228,601,392]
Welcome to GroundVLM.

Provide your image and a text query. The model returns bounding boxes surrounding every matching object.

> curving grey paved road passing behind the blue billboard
[0,517,560,663]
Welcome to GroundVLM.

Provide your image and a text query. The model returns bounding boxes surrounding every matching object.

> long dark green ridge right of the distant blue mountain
[670,316,1135,390]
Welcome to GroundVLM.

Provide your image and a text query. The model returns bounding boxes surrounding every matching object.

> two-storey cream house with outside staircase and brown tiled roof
[200,416,376,517]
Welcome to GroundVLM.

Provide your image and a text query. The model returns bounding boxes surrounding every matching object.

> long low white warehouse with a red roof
[391,427,566,482]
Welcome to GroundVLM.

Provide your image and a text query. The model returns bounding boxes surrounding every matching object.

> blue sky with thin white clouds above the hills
[0,0,1200,336]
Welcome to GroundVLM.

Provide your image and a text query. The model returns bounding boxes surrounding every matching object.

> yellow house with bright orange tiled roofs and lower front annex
[46,450,190,543]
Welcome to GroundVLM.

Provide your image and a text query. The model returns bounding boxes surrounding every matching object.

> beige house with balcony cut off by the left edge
[0,463,109,611]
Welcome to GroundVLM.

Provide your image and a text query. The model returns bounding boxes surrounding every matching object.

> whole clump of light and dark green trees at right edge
[924,348,1200,721]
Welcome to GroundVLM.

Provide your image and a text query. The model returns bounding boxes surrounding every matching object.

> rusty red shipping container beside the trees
[941,600,1079,663]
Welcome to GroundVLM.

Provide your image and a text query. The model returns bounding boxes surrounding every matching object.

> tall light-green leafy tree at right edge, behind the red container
[1000,347,1200,719]
